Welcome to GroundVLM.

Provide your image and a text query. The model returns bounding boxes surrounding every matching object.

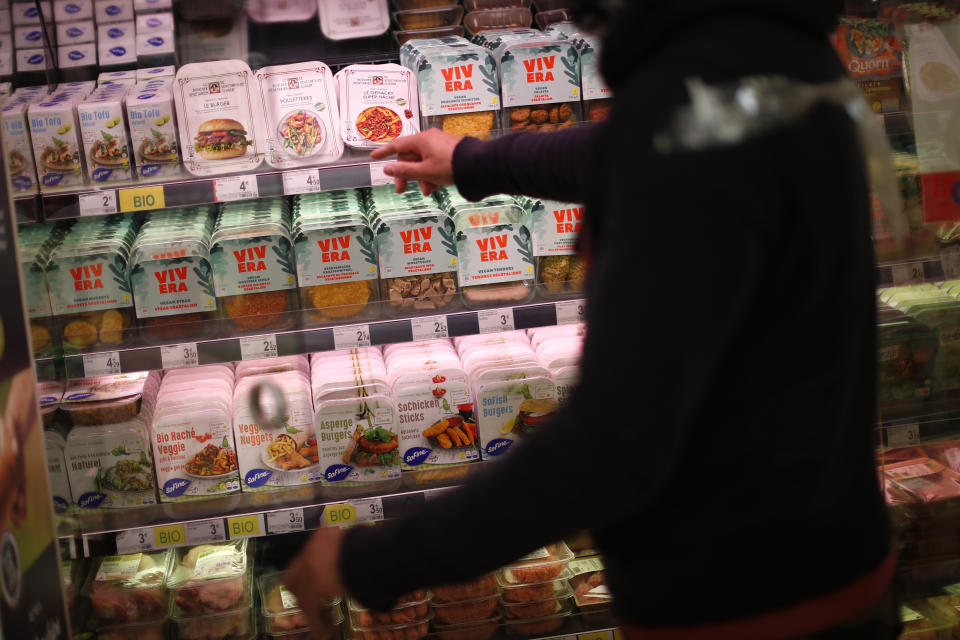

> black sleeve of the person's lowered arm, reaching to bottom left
[340,152,764,608]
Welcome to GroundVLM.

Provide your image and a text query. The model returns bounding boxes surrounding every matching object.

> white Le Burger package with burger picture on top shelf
[173,60,266,176]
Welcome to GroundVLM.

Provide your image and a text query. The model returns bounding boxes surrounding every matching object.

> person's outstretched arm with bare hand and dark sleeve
[370,124,602,202]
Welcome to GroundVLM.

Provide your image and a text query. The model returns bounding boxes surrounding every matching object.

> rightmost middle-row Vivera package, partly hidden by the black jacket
[530,200,586,294]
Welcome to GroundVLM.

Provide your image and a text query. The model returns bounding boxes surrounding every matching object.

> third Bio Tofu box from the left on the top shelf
[77,84,133,184]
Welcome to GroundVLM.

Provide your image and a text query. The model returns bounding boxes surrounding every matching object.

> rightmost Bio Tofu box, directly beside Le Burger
[127,82,180,178]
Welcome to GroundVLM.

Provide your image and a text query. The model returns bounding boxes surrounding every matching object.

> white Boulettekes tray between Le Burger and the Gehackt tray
[257,62,343,169]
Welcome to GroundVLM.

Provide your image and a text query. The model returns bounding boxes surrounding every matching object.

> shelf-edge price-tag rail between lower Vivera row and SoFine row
[43,299,584,380]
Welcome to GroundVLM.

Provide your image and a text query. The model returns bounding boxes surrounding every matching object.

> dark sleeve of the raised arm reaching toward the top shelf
[453,124,601,202]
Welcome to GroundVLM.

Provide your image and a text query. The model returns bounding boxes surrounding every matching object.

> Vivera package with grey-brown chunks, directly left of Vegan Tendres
[376,209,459,315]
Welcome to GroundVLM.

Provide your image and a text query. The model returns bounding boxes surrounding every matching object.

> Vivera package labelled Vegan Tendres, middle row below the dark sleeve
[453,203,535,309]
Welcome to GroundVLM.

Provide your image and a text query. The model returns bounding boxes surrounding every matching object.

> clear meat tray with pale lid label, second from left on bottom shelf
[166,538,253,621]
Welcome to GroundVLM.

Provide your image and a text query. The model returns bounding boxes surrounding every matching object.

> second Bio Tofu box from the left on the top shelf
[27,92,83,190]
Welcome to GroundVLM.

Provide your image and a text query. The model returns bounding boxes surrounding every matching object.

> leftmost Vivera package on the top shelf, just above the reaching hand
[411,45,500,139]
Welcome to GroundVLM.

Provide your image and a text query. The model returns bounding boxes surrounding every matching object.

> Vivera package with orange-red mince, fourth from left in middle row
[210,208,299,335]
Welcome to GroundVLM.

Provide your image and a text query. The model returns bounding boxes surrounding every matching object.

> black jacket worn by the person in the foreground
[341,0,890,637]
